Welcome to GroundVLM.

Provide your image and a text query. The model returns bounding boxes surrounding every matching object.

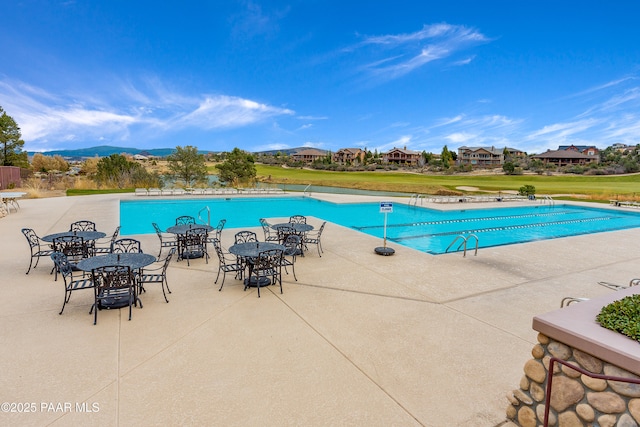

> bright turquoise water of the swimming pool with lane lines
[120,197,640,254]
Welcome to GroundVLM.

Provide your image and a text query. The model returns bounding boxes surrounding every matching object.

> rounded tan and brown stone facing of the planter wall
[507,334,640,427]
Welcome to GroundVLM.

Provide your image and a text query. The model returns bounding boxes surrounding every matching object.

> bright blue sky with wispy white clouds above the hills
[0,0,640,153]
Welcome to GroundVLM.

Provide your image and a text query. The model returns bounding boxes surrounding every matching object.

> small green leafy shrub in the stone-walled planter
[596,294,640,341]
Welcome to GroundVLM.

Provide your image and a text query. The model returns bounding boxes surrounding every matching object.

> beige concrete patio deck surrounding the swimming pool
[0,195,640,426]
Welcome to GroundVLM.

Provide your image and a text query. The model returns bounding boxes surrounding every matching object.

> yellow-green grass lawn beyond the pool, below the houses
[256,165,640,201]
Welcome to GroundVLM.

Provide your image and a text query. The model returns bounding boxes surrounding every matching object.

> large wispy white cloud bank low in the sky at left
[0,79,294,150]
